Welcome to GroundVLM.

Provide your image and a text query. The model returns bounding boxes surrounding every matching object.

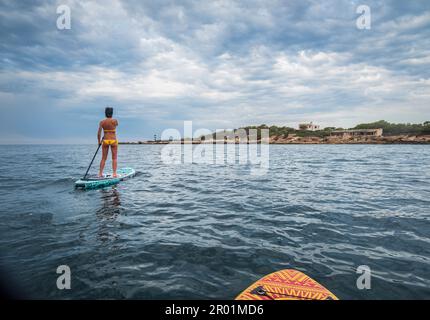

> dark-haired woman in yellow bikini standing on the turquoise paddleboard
[97,107,118,177]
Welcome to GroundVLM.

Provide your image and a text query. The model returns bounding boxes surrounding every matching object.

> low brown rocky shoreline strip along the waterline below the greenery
[120,135,430,145]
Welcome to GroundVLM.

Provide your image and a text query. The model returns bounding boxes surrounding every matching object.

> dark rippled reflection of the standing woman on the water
[96,187,121,242]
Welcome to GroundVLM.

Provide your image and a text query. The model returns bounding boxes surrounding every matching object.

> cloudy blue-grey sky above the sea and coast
[0,0,430,143]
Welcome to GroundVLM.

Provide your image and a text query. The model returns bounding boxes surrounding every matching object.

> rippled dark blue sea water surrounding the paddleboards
[0,145,430,299]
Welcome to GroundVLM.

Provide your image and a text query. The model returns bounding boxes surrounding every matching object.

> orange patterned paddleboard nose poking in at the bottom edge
[236,269,339,300]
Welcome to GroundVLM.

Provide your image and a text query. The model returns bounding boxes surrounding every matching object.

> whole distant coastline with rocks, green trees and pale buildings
[120,120,430,145]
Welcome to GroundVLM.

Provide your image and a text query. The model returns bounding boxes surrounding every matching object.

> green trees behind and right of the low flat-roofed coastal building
[353,120,430,136]
